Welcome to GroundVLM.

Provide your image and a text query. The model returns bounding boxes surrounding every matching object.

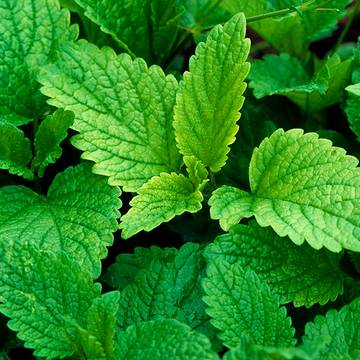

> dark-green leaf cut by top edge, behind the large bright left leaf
[76,0,179,63]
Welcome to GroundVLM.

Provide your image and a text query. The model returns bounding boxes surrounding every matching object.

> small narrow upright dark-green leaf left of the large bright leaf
[32,109,74,177]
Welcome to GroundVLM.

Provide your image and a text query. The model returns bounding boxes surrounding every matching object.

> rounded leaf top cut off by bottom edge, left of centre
[117,319,219,360]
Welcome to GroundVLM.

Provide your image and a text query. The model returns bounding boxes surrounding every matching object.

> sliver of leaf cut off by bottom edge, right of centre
[223,337,311,360]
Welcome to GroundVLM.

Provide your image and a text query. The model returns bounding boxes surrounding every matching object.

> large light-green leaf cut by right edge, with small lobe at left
[209,129,360,252]
